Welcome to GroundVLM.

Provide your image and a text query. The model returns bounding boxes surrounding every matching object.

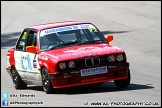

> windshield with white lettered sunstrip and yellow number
[40,24,107,51]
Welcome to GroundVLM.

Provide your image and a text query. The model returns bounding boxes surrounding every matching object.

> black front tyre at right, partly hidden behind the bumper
[114,69,131,88]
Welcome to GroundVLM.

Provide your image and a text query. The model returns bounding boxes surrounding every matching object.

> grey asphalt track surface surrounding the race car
[1,1,161,107]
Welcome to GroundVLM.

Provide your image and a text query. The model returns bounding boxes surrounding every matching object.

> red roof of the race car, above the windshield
[28,21,90,31]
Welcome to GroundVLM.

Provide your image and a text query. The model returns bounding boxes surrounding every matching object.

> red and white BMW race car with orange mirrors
[6,21,130,94]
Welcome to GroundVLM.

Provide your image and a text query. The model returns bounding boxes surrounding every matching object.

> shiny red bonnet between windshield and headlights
[40,43,123,61]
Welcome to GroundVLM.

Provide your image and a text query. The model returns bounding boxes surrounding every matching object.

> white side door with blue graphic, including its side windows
[14,29,41,85]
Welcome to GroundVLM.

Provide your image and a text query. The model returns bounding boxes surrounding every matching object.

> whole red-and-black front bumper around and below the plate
[49,63,129,88]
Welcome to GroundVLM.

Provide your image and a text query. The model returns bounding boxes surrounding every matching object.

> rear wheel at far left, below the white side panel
[11,67,27,89]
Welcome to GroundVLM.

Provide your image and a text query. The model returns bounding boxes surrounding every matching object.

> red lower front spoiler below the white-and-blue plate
[51,67,128,88]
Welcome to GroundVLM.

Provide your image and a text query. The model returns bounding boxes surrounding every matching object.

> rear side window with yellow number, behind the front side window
[16,30,29,51]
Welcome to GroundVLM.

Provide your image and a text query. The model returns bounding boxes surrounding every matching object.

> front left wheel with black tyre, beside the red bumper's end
[42,68,53,94]
